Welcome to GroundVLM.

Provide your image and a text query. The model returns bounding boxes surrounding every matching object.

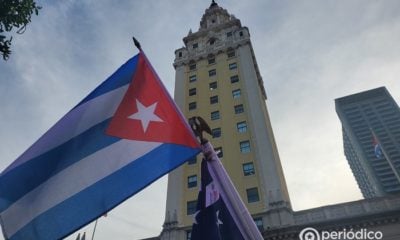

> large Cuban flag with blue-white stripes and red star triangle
[0,52,200,240]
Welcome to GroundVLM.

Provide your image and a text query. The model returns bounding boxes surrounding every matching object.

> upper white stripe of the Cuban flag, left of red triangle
[4,84,129,173]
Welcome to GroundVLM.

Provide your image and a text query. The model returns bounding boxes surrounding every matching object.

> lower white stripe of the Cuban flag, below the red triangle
[0,139,162,236]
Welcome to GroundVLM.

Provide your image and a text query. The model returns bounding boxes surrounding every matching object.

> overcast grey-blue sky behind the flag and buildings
[0,0,400,240]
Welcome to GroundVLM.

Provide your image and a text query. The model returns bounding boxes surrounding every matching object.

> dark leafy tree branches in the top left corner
[0,0,41,60]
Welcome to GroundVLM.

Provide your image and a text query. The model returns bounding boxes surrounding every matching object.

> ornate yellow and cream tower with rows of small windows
[161,1,292,240]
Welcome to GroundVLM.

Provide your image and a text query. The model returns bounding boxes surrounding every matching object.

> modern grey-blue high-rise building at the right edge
[335,87,400,198]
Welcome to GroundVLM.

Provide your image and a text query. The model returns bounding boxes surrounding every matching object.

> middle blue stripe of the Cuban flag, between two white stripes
[0,119,121,212]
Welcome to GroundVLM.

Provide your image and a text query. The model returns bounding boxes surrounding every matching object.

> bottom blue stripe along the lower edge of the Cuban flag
[10,144,199,240]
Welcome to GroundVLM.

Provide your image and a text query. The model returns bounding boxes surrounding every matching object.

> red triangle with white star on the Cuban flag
[106,52,199,147]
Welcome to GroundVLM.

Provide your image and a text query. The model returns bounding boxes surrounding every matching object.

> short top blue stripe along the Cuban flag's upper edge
[75,55,139,108]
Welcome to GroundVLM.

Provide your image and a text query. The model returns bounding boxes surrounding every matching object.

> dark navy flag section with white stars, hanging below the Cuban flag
[191,159,244,240]
